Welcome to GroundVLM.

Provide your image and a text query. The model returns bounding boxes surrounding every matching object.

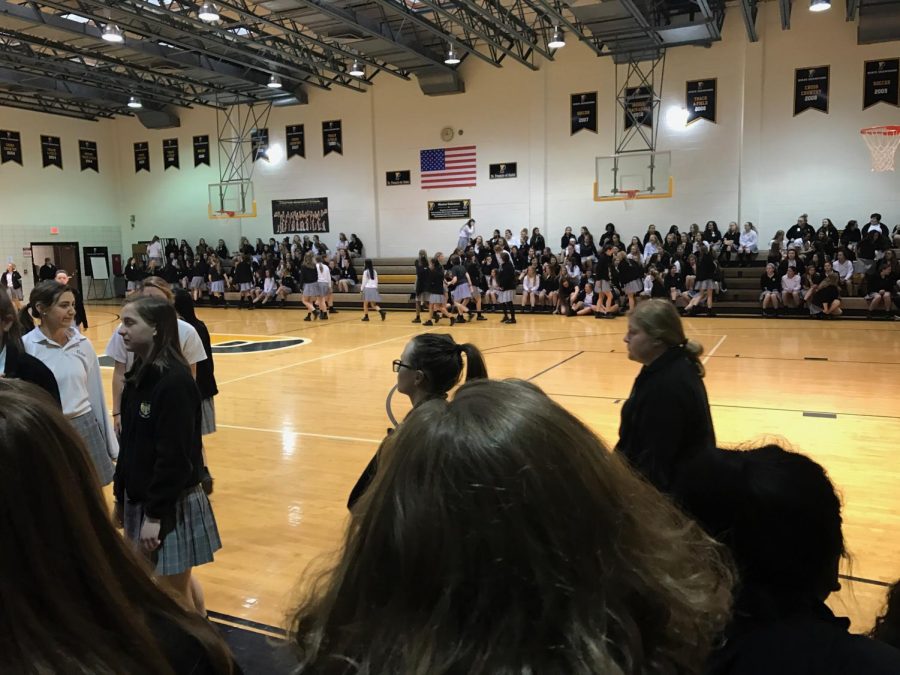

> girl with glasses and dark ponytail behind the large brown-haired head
[347,333,487,509]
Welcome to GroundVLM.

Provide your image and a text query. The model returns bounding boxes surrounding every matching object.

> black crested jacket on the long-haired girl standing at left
[113,364,203,538]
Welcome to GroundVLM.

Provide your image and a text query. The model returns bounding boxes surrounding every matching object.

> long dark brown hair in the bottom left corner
[0,379,232,675]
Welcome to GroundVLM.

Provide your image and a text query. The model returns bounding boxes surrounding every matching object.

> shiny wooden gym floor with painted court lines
[81,305,900,631]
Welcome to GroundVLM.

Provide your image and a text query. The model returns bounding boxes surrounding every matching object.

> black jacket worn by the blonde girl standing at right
[616,347,716,492]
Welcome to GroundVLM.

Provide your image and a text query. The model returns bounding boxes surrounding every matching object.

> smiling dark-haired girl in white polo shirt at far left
[19,281,119,485]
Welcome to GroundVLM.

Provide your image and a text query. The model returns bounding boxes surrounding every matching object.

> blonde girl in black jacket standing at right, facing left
[616,299,716,492]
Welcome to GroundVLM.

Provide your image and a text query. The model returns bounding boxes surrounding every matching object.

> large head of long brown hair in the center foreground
[291,380,733,675]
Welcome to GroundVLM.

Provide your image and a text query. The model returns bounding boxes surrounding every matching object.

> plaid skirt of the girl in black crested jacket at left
[122,484,222,576]
